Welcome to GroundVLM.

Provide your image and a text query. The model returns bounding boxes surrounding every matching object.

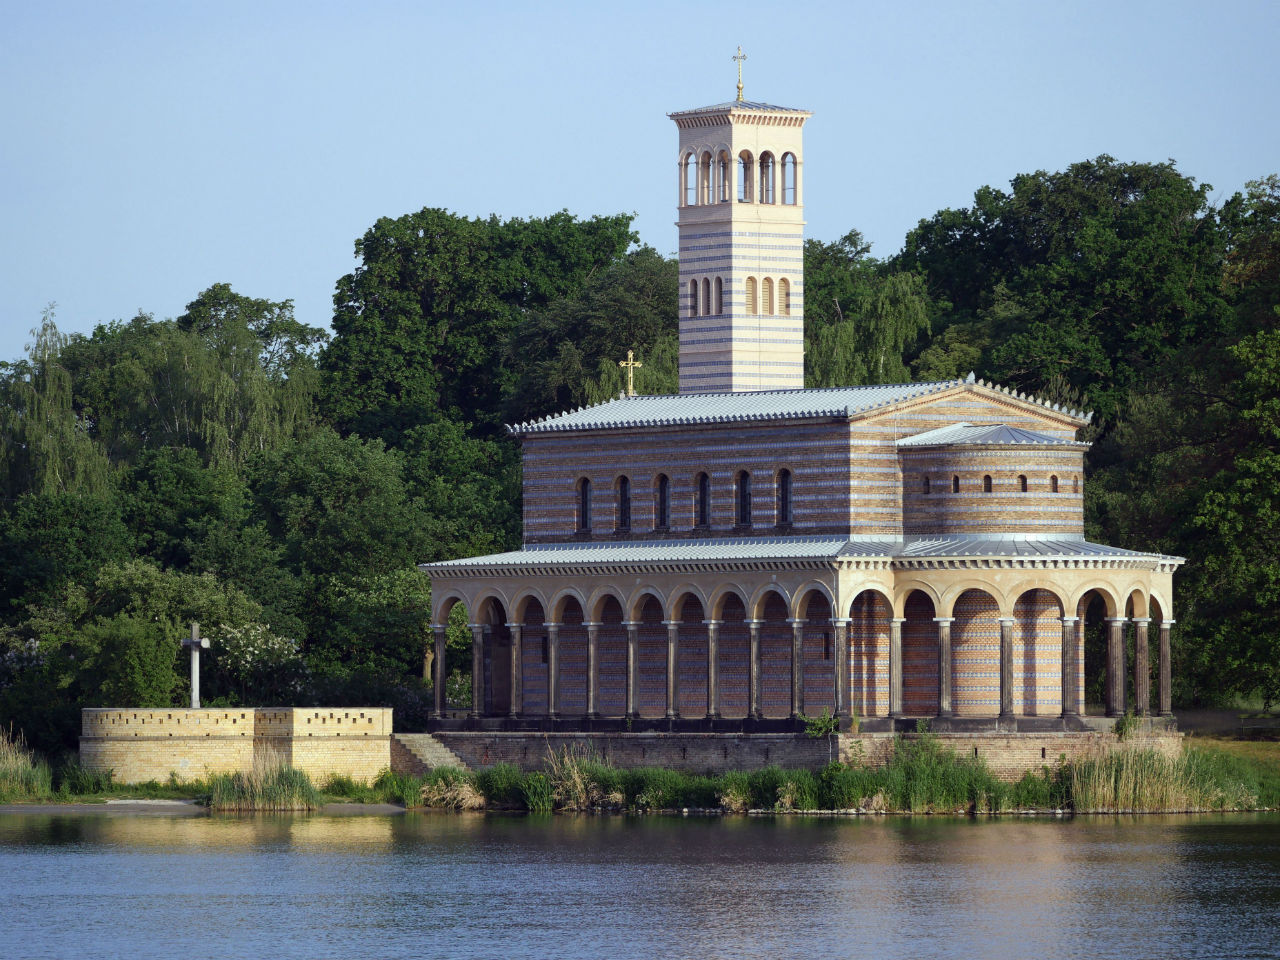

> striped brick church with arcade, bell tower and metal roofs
[422,84,1183,735]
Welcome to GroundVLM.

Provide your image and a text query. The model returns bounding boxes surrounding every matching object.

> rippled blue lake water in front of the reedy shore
[0,814,1280,960]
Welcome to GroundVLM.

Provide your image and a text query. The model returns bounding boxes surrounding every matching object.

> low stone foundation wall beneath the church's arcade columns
[427,731,1183,781]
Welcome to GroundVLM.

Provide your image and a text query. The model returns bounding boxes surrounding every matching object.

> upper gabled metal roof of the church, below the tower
[507,374,1092,436]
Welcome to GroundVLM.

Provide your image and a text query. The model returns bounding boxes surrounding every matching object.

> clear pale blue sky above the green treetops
[0,0,1280,360]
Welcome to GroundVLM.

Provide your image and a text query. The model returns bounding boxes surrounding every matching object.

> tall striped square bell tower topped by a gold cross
[669,68,813,393]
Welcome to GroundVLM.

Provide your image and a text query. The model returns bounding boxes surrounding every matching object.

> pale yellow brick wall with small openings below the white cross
[79,707,392,783]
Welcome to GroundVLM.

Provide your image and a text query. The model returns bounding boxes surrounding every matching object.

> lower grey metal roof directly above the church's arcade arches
[422,534,1181,572]
